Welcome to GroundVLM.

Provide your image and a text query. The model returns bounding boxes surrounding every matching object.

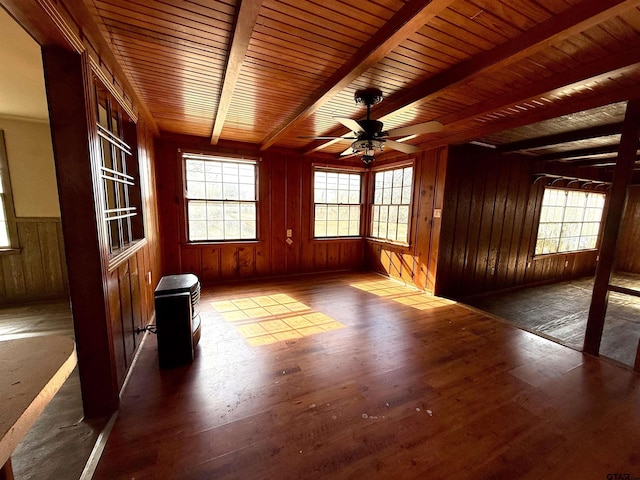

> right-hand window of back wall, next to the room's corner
[313,169,362,238]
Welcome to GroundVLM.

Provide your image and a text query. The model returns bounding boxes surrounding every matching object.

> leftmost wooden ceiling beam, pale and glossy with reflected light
[211,0,262,145]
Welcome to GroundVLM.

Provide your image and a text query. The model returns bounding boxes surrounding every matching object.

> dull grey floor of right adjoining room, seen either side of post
[460,273,640,367]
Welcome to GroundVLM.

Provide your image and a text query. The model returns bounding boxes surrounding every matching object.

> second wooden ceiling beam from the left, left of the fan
[255,0,453,150]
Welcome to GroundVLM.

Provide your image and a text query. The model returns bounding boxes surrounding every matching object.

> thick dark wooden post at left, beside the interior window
[43,46,119,417]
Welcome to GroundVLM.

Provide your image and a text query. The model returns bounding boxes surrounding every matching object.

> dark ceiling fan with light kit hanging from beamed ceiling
[301,88,443,166]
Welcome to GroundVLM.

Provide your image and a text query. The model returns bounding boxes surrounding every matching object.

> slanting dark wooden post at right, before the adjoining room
[583,100,640,355]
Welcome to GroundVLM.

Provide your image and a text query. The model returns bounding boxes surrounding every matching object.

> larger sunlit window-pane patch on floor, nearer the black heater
[212,293,344,346]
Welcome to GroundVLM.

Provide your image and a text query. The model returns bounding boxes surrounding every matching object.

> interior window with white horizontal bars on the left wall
[96,80,144,255]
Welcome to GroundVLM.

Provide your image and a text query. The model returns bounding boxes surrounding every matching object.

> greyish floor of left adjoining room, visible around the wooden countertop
[0,300,106,480]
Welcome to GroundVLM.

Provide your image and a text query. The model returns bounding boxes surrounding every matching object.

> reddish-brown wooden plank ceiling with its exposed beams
[84,0,640,171]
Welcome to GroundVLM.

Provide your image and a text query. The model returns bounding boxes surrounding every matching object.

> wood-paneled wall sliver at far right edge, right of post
[616,185,640,273]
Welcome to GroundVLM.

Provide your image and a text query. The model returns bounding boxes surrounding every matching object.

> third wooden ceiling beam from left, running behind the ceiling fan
[303,0,640,154]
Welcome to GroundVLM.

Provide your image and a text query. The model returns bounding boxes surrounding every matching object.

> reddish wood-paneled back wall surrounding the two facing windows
[156,136,363,283]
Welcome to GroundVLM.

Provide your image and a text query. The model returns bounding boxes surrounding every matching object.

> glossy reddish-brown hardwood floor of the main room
[94,274,640,480]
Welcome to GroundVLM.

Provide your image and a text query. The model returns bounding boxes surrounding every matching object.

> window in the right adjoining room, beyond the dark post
[535,188,604,255]
